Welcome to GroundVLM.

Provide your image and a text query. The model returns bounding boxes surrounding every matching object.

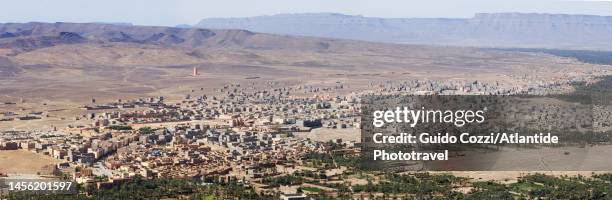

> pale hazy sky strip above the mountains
[0,0,612,26]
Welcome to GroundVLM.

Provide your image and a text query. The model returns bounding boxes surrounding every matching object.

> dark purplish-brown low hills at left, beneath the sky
[0,22,344,51]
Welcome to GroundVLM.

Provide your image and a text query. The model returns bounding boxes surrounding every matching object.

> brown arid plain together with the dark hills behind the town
[0,23,605,130]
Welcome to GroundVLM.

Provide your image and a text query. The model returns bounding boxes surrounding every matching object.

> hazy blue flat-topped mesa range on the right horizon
[195,13,612,50]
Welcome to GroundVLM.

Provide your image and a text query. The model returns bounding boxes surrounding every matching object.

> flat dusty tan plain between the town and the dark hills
[0,38,601,130]
